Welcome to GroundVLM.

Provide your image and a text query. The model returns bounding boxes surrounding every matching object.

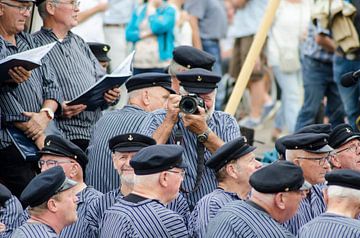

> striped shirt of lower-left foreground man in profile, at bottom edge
[12,222,58,238]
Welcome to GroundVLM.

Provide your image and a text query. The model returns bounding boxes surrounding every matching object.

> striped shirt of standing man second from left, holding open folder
[33,28,104,140]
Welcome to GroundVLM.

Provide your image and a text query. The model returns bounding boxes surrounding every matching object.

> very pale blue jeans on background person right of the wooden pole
[272,66,302,133]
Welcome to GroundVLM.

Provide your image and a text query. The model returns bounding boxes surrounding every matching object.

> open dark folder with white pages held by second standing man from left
[67,51,135,111]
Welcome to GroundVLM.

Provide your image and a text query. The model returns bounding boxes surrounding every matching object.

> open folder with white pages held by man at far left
[0,42,56,81]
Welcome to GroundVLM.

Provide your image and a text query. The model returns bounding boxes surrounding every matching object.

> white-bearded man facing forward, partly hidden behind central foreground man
[86,133,190,237]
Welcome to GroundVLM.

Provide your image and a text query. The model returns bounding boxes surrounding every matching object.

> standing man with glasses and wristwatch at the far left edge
[0,0,62,197]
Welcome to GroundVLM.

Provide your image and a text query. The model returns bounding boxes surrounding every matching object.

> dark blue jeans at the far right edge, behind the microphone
[334,56,360,129]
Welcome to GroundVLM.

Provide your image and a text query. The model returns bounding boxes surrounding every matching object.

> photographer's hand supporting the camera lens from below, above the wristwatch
[182,106,208,135]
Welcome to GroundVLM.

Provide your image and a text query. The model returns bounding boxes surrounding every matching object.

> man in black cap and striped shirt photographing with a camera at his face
[148,68,240,209]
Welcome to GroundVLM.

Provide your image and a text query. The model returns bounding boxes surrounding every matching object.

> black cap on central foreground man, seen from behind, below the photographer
[130,145,187,175]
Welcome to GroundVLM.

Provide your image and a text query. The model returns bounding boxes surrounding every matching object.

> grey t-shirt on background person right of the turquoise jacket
[185,0,228,39]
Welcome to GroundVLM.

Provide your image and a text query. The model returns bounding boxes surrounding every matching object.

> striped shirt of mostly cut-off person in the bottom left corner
[0,195,23,238]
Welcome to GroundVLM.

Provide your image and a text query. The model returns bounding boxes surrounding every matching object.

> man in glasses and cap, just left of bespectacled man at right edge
[282,133,333,235]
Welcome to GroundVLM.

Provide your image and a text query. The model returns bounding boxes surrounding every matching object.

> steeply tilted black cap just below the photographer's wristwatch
[206,136,256,171]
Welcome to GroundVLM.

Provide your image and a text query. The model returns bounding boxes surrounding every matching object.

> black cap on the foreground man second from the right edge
[249,160,311,193]
